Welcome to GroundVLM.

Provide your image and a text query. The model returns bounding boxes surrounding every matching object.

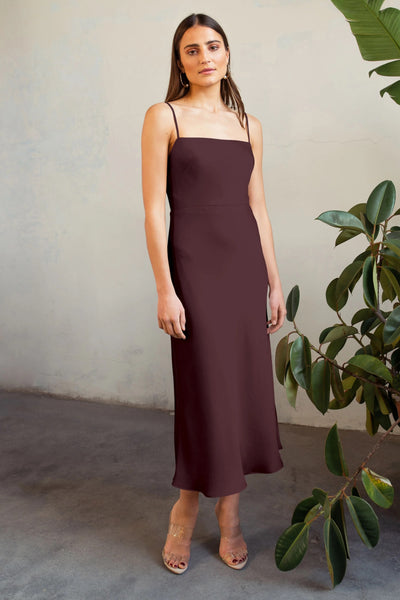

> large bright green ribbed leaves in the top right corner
[331,0,400,104]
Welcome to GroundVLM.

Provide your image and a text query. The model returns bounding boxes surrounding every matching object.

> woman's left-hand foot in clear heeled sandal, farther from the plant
[162,498,199,574]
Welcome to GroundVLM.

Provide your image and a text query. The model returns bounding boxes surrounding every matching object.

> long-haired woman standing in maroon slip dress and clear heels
[142,14,286,574]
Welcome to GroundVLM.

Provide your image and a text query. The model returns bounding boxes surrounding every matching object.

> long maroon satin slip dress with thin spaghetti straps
[167,102,283,497]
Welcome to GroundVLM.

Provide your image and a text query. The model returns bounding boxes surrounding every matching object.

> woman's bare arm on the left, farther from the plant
[141,102,186,339]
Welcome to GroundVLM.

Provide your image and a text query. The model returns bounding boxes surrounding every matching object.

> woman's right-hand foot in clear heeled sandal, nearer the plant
[215,500,248,569]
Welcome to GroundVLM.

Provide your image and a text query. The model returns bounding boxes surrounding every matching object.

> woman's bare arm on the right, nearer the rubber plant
[247,115,286,333]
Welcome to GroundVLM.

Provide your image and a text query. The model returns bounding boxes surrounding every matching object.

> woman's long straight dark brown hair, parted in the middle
[165,13,244,127]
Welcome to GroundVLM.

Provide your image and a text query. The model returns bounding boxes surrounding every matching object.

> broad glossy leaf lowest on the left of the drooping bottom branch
[275,523,310,571]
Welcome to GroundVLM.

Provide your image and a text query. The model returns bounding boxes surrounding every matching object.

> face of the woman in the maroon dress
[178,25,229,86]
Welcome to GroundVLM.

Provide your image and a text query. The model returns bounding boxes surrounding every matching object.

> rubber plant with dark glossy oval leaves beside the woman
[275,180,400,586]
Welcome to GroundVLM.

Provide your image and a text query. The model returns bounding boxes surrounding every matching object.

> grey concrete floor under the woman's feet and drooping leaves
[0,392,400,600]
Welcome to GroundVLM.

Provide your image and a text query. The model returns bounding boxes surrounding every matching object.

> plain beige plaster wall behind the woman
[0,0,400,428]
